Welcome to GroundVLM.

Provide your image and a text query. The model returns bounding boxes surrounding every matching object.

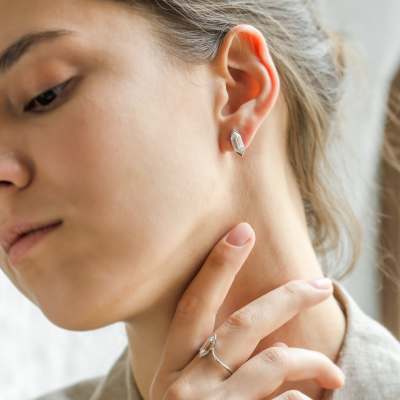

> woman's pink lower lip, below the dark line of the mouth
[7,221,62,266]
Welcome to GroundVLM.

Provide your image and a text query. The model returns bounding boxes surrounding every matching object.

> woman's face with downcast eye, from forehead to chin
[0,0,229,330]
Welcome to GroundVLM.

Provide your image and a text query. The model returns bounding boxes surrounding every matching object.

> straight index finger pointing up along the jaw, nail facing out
[161,223,255,373]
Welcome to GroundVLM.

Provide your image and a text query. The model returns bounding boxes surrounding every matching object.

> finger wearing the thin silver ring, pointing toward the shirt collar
[208,278,333,376]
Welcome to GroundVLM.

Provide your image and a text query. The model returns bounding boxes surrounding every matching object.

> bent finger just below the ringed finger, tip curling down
[221,347,345,399]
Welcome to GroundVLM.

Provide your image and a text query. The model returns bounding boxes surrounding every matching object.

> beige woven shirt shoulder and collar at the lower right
[332,282,400,400]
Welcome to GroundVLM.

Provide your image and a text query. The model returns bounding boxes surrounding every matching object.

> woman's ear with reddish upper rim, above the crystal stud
[211,25,280,153]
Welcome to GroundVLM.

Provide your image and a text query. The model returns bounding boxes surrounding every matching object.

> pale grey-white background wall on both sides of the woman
[0,0,400,400]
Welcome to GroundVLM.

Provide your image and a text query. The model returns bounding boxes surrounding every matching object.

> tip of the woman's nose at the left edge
[0,152,31,193]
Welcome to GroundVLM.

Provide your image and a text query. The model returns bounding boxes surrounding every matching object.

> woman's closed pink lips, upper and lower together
[0,220,62,265]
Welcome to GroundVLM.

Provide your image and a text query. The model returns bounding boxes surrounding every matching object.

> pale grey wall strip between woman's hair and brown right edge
[316,0,400,320]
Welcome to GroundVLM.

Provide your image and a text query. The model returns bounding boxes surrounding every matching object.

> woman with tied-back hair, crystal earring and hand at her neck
[0,0,400,400]
